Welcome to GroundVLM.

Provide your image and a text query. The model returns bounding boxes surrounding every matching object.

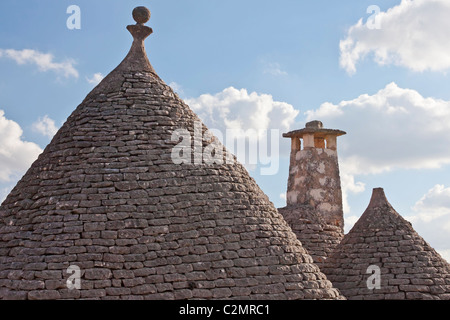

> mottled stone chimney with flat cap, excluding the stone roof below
[283,121,346,230]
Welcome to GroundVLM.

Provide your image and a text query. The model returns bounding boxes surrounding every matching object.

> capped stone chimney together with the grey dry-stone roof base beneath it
[278,121,345,267]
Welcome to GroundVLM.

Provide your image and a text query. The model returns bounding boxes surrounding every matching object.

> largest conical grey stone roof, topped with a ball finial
[0,8,340,299]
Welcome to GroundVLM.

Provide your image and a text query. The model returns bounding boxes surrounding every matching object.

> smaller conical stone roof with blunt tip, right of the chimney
[322,188,450,300]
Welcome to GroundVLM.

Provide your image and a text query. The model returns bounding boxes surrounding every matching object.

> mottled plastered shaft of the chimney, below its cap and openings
[287,148,344,230]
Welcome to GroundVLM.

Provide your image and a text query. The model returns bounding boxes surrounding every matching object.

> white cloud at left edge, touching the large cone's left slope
[0,110,42,182]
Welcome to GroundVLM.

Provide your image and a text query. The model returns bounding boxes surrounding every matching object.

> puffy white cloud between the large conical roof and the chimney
[186,87,299,175]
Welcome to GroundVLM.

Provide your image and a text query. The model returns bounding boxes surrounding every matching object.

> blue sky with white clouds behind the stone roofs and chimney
[0,0,450,260]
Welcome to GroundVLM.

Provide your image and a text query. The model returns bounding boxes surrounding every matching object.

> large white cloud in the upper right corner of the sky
[340,0,450,74]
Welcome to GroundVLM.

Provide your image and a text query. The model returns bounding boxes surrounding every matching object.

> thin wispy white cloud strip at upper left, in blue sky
[0,49,79,78]
